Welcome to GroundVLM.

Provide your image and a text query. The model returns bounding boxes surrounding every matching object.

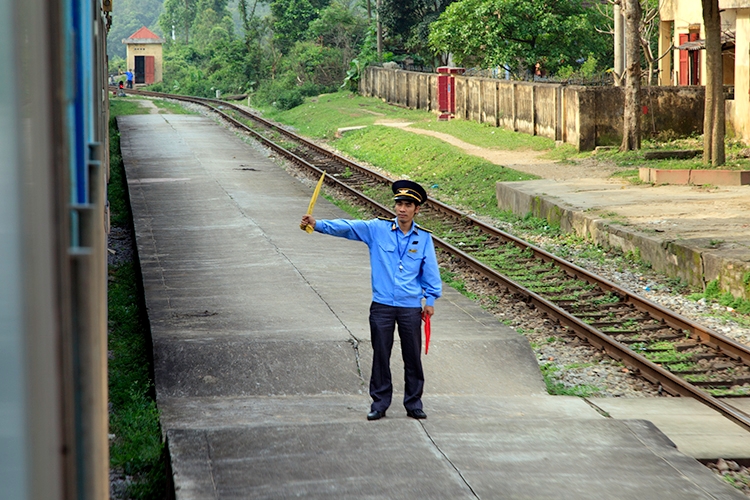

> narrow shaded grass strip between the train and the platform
[107,99,167,499]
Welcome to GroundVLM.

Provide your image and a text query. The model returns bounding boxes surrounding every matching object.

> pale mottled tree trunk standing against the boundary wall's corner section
[620,0,642,151]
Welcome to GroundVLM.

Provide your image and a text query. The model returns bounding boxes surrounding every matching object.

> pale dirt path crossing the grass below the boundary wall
[375,120,618,180]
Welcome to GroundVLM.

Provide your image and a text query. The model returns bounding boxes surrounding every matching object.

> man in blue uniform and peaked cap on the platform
[302,180,442,420]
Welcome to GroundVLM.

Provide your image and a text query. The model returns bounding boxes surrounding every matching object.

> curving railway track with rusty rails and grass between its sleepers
[123,91,750,430]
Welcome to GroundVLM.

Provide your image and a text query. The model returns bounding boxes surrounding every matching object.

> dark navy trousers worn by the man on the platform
[370,302,424,412]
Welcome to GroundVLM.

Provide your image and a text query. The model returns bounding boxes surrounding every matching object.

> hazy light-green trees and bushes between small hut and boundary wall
[148,0,368,104]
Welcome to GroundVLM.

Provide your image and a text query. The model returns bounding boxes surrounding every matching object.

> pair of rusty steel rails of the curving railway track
[123,91,750,431]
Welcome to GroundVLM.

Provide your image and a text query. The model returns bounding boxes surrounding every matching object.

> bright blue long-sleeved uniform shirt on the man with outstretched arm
[315,219,443,307]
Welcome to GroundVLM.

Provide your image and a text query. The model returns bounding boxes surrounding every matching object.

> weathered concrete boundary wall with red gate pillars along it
[359,66,705,151]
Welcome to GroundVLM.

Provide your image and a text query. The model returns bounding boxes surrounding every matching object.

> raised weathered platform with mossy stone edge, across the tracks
[496,179,750,299]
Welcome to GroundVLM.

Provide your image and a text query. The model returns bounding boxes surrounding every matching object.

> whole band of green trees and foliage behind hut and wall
[108,0,658,104]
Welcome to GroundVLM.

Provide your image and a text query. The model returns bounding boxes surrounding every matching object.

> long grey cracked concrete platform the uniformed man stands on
[118,115,744,500]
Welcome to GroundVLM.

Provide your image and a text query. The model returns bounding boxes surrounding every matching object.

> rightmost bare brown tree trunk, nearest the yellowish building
[701,0,726,166]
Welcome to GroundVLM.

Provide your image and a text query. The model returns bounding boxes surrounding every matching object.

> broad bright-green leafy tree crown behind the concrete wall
[429,0,612,75]
